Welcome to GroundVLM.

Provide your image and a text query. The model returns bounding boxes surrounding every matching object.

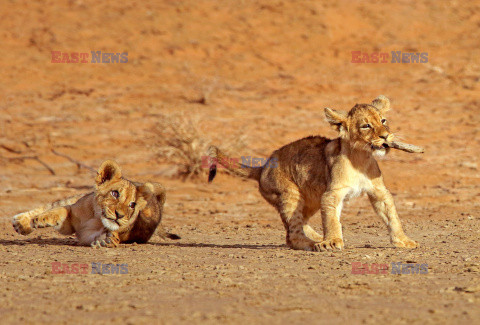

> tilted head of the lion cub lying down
[95,160,147,231]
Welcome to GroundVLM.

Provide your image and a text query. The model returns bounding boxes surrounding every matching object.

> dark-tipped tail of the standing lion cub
[208,146,263,183]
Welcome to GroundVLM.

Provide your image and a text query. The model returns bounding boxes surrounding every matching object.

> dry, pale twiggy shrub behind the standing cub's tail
[154,112,246,181]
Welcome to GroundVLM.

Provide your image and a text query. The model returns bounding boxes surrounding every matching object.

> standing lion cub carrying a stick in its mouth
[209,96,419,251]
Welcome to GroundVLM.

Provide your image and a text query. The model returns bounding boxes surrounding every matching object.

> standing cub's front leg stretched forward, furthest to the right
[368,182,420,248]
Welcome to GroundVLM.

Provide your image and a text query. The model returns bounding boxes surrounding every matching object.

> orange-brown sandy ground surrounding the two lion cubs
[0,0,480,324]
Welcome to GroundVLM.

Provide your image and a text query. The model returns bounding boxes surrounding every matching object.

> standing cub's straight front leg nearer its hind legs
[315,189,346,251]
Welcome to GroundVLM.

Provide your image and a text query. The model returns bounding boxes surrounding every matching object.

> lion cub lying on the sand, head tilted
[13,160,180,247]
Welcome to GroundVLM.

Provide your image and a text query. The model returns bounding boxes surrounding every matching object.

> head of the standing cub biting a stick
[325,95,393,156]
